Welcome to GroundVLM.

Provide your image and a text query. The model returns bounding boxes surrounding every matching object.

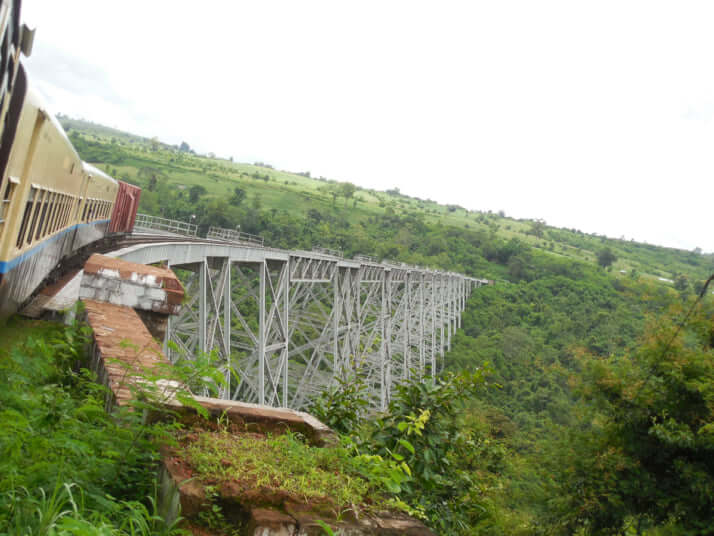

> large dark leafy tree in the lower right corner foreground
[560,304,714,534]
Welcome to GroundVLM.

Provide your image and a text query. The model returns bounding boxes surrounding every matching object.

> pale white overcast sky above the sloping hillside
[23,0,714,252]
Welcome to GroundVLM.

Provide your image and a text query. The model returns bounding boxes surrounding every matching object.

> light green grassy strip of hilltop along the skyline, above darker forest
[62,117,714,281]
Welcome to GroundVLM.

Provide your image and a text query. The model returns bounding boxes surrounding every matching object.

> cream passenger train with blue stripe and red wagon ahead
[0,0,141,319]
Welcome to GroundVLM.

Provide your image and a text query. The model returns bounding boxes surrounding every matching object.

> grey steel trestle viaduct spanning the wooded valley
[110,221,487,409]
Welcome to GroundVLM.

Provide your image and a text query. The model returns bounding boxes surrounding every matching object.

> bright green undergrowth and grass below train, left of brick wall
[0,321,186,536]
